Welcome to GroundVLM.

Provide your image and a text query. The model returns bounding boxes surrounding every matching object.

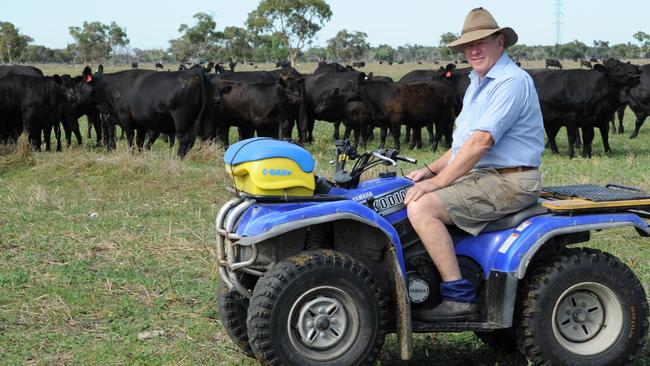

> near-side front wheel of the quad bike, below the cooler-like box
[248,250,388,366]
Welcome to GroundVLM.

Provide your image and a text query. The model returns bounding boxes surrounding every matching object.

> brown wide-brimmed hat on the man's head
[447,8,518,52]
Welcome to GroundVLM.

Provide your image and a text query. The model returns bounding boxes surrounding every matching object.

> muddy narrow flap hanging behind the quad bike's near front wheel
[390,245,413,361]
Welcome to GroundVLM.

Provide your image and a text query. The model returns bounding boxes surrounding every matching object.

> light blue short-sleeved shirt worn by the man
[450,52,544,168]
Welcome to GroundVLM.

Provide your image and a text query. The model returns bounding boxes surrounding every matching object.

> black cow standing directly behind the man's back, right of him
[528,60,641,158]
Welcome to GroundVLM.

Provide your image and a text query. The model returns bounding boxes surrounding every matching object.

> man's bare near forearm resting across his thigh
[404,130,494,205]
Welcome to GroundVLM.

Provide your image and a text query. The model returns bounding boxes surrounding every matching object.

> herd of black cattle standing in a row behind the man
[0,59,650,157]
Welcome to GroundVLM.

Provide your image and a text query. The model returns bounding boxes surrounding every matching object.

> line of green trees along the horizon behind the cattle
[0,0,650,64]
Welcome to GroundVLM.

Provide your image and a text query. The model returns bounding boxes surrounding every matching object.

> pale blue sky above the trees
[5,0,650,49]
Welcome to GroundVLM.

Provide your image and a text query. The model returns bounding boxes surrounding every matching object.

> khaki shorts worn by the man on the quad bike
[434,168,542,236]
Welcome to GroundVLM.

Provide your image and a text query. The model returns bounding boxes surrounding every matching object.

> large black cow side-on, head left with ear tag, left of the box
[77,67,227,158]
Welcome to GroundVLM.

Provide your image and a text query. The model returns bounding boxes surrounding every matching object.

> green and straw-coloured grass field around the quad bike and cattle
[0,65,650,366]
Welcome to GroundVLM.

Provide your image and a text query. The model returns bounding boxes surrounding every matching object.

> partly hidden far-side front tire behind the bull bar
[217,286,255,357]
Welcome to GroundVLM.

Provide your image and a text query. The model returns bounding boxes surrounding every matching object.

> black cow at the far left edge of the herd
[0,73,74,151]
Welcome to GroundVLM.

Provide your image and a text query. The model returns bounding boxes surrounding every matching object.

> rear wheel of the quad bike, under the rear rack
[517,248,648,366]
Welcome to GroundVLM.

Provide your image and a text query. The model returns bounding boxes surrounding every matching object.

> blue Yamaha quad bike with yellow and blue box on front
[215,138,650,366]
